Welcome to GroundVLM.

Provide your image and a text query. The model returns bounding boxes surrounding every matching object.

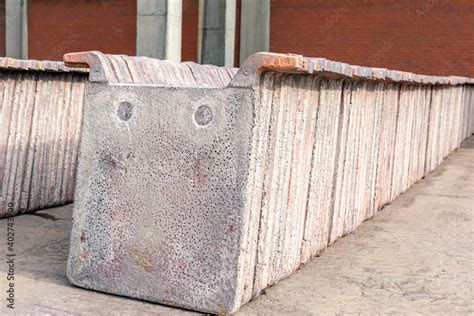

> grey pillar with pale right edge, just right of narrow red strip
[199,0,236,67]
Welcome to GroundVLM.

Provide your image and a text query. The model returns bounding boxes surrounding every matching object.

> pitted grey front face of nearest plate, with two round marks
[68,85,252,312]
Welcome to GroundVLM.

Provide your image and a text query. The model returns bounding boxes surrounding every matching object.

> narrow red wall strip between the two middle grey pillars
[181,0,199,62]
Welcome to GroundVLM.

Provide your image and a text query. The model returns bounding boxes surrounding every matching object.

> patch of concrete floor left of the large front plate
[0,205,196,315]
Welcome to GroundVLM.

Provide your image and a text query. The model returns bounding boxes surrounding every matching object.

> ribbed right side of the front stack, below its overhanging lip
[241,72,474,303]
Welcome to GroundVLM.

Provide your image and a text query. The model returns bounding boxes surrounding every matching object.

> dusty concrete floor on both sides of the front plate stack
[0,137,474,315]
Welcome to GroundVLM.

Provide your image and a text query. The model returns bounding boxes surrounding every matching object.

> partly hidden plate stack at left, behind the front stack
[0,58,87,217]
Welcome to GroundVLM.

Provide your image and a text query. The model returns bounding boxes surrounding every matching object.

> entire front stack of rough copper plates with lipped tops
[66,52,474,313]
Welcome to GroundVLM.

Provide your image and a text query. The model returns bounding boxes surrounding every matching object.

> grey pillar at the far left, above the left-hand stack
[5,0,28,59]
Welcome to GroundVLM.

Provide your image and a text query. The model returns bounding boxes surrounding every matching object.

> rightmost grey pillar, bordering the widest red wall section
[240,0,270,64]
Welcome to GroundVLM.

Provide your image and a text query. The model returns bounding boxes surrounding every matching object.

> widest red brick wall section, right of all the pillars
[270,0,474,77]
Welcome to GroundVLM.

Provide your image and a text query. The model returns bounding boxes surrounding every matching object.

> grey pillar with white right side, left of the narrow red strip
[137,0,182,61]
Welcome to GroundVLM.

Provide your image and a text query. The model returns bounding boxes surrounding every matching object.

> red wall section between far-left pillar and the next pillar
[28,0,137,60]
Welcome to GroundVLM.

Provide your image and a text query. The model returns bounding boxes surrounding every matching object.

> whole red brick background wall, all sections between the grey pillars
[0,0,474,77]
